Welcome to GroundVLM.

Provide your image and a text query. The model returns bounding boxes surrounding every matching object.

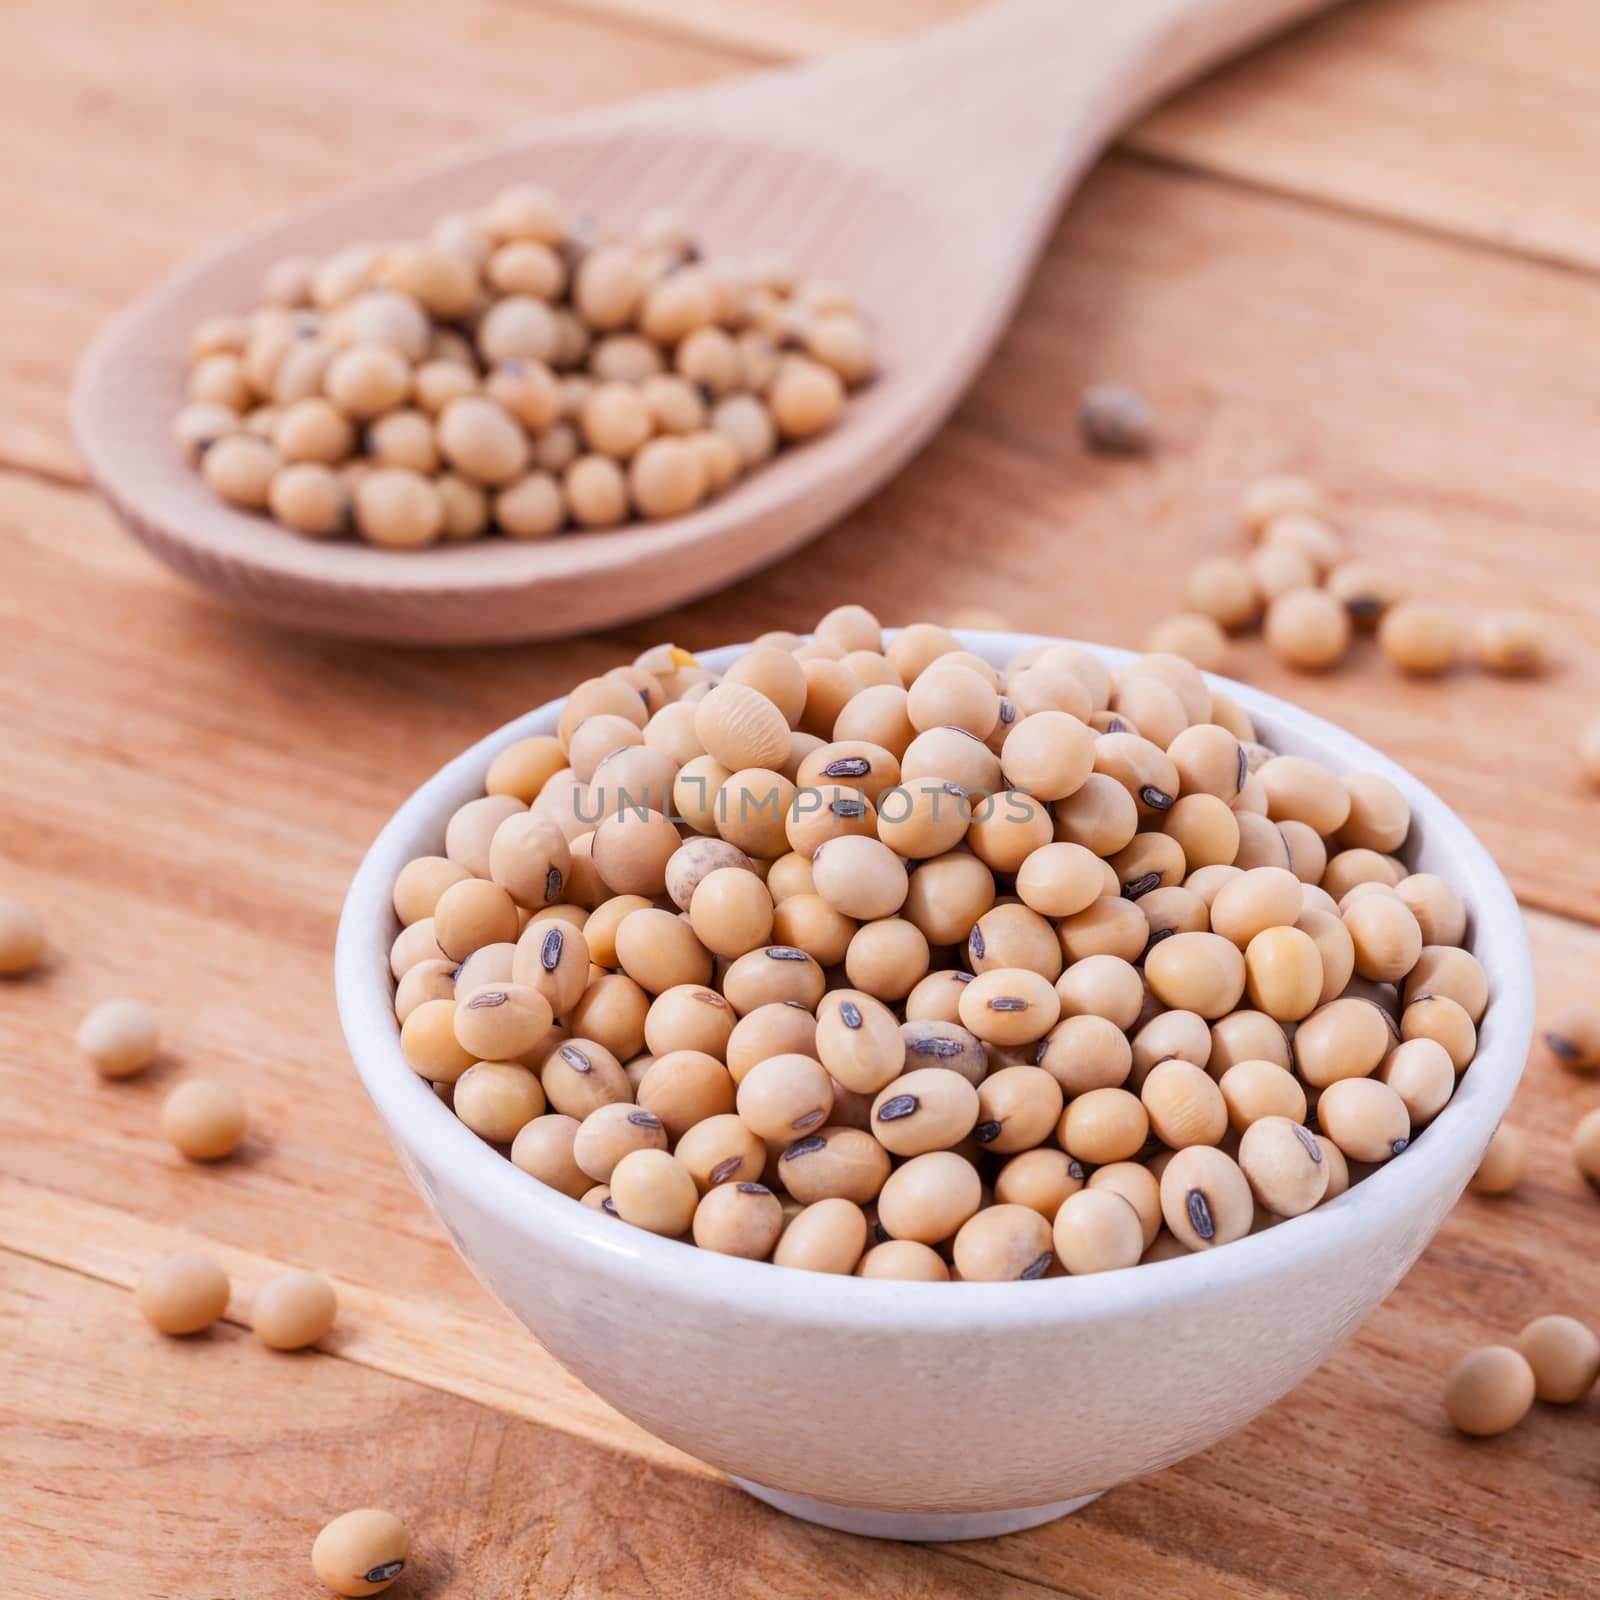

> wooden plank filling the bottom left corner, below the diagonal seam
[0,1251,1075,1600]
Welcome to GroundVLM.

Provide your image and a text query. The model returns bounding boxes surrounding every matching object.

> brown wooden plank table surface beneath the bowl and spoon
[0,0,1600,1600]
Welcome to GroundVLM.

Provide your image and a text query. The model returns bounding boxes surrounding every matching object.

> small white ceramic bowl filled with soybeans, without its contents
[338,632,1533,1539]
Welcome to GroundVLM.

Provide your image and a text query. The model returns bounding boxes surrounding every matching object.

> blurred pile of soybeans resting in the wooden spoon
[176,187,874,549]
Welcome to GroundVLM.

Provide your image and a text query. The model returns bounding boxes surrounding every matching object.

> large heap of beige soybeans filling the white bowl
[392,606,1490,1282]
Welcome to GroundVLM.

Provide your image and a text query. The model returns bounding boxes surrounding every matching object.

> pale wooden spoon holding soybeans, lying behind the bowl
[72,0,1330,643]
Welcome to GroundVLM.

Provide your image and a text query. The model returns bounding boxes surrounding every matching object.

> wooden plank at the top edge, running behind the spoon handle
[550,0,1600,269]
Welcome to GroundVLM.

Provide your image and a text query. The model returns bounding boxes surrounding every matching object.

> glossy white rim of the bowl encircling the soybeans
[334,629,1534,1333]
